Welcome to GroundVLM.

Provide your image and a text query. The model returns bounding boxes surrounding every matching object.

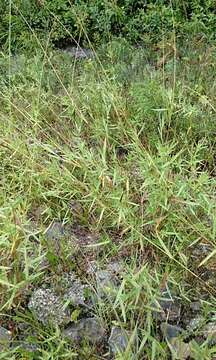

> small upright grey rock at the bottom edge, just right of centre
[109,326,129,354]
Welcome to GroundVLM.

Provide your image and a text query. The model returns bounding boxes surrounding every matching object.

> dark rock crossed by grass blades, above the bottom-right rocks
[152,291,181,321]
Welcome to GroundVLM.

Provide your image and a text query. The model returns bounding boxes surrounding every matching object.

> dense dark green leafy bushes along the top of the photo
[0,0,216,48]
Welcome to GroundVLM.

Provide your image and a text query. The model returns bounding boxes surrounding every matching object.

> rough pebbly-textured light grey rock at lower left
[28,289,70,325]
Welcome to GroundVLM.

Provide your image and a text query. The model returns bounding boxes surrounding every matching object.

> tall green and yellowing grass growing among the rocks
[0,30,216,360]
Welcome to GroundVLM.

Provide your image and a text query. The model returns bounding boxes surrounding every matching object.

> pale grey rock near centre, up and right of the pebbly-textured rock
[95,270,117,298]
